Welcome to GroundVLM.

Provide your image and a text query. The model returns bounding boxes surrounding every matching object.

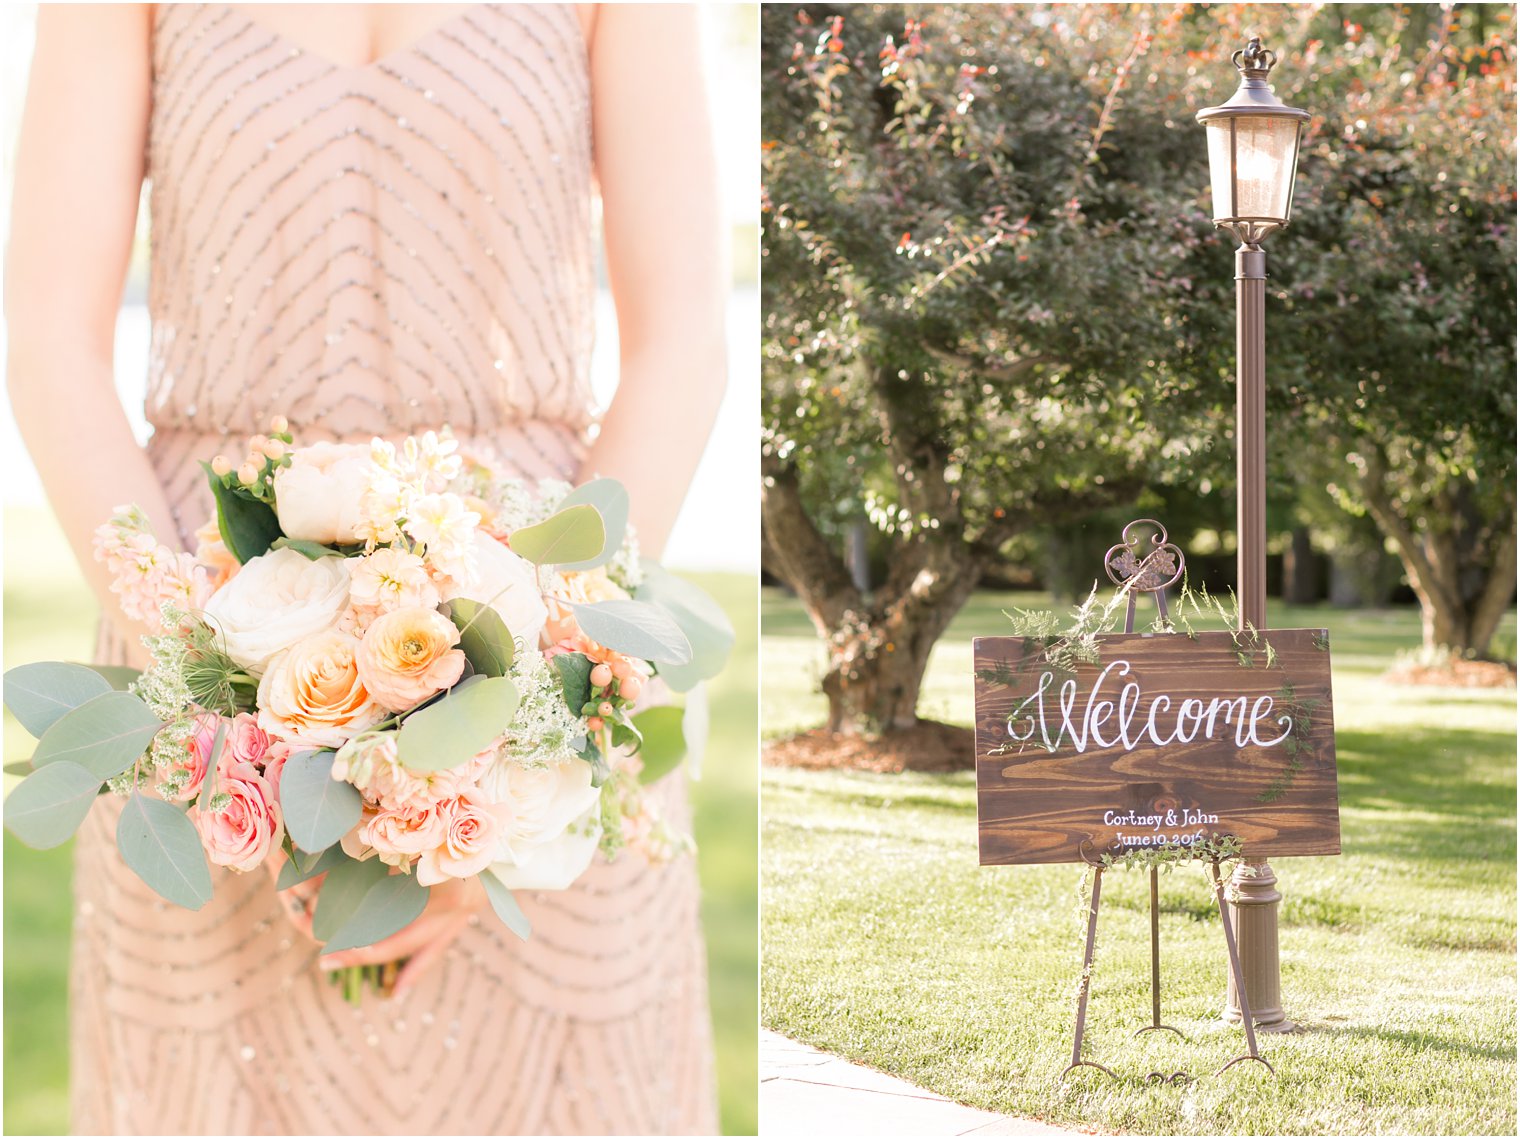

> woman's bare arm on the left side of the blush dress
[5,5,181,647]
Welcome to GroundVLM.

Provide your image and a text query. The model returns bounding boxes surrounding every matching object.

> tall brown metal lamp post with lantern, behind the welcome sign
[1198,38,1309,1033]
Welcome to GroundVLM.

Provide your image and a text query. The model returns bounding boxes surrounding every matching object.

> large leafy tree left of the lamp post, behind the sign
[762,6,1231,730]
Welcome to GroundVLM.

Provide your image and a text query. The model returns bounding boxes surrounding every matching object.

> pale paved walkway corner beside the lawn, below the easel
[760,1031,1079,1139]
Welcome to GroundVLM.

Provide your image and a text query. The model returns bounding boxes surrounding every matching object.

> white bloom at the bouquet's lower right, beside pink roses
[480,759,602,890]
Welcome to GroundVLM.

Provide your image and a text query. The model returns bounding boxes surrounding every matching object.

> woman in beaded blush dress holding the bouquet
[5,5,724,1134]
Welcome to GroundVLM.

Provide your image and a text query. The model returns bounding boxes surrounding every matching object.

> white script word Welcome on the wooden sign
[1008,660,1294,754]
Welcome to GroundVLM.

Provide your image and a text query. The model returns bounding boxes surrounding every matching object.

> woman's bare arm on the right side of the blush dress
[584,5,728,557]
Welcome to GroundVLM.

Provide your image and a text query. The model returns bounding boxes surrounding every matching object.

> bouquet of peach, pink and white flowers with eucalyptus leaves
[5,418,733,985]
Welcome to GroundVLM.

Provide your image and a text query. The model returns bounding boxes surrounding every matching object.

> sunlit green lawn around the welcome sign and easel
[762,580,1515,1134]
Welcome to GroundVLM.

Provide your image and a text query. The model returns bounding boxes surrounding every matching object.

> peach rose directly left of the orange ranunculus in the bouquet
[258,630,386,748]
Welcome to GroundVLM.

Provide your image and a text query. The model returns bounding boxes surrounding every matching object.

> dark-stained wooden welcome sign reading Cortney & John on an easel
[974,630,1341,865]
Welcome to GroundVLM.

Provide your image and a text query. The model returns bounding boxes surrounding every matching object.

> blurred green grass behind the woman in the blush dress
[5,509,758,1134]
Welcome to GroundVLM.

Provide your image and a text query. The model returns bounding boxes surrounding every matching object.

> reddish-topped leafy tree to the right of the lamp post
[1268,5,1515,655]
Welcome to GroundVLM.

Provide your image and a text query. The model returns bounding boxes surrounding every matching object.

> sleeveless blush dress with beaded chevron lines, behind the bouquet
[71,5,716,1134]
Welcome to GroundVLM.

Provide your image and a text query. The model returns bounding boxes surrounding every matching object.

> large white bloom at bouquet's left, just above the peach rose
[205,549,350,677]
